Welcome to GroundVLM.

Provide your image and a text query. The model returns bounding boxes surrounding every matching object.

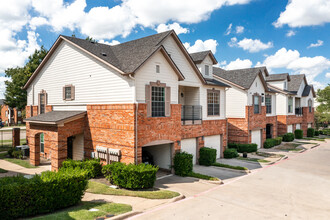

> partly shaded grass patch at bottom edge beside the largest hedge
[32,202,132,220]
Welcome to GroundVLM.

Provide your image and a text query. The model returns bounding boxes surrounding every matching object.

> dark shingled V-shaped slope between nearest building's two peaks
[62,31,171,73]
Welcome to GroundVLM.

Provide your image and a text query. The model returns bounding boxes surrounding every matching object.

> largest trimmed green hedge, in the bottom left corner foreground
[0,169,87,219]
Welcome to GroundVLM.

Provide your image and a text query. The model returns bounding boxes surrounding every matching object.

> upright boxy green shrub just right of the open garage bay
[174,152,193,176]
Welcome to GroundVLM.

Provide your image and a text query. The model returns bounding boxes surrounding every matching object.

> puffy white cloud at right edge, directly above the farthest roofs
[262,47,330,81]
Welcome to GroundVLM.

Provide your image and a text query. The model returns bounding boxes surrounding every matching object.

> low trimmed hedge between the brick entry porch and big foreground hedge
[60,159,102,178]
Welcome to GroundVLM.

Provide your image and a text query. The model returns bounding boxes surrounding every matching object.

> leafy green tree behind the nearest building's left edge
[5,46,48,110]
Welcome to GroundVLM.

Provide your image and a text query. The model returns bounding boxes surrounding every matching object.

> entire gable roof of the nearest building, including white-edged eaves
[23,30,206,89]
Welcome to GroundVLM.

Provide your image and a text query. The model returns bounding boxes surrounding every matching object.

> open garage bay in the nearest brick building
[142,143,172,170]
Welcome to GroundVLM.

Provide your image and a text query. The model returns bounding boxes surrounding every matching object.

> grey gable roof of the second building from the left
[213,67,268,90]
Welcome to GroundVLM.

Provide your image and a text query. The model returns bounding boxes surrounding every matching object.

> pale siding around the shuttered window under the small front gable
[135,51,178,104]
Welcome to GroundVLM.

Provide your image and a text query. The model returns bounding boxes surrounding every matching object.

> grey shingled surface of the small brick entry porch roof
[25,111,86,124]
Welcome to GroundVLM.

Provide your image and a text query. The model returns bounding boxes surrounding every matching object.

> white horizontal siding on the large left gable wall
[28,41,134,105]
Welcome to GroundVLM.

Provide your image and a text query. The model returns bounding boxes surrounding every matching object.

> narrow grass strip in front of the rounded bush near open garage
[86,181,180,199]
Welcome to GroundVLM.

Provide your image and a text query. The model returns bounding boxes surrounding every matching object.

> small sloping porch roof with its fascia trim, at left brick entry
[24,111,86,126]
